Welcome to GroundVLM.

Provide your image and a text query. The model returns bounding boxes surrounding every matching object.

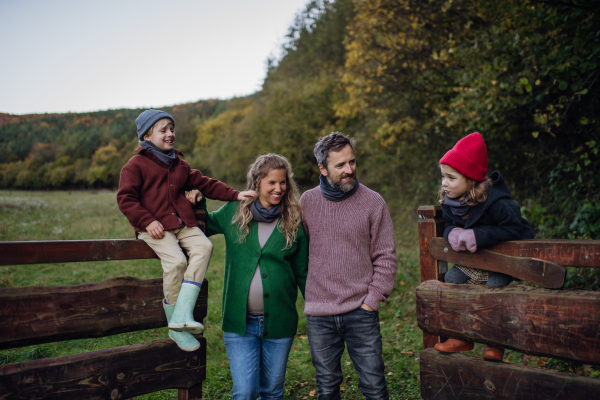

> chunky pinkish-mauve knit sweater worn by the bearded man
[300,185,398,316]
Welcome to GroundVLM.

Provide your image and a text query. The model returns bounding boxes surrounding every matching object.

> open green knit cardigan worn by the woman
[206,201,308,339]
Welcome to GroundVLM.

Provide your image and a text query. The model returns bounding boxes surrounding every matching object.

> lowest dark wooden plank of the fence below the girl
[421,349,600,400]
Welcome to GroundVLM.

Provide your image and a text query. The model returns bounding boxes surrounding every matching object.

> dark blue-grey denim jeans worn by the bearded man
[306,307,389,400]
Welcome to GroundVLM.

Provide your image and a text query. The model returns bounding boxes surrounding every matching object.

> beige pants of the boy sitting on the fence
[138,227,213,304]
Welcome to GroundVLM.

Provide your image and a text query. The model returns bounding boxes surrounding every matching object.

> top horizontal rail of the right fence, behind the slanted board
[488,239,600,268]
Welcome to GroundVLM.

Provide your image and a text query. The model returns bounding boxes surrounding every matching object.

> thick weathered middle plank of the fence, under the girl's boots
[416,280,600,365]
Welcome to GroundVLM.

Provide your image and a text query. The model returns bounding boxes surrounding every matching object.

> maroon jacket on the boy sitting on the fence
[117,147,240,232]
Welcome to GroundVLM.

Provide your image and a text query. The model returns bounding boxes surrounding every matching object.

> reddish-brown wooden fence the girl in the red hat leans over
[416,206,600,400]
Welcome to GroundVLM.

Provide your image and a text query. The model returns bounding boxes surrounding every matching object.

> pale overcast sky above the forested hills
[0,0,308,114]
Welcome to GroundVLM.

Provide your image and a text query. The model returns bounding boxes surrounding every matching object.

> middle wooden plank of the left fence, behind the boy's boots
[0,277,208,349]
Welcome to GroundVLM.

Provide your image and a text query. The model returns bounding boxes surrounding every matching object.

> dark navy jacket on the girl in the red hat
[442,171,533,248]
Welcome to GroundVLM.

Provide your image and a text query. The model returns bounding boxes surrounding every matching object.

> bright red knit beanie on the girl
[440,132,487,182]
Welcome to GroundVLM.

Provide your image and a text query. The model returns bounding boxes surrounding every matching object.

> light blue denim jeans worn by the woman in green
[223,315,294,400]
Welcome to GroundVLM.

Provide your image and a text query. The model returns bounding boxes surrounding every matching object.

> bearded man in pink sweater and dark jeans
[300,132,398,400]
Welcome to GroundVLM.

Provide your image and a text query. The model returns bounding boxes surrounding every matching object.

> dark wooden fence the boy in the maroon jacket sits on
[0,210,208,400]
